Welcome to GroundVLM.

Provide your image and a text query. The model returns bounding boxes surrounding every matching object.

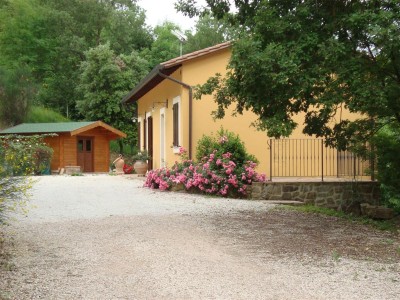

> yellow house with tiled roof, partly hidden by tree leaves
[122,42,368,176]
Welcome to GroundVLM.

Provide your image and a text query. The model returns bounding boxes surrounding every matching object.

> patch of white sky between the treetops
[137,0,204,31]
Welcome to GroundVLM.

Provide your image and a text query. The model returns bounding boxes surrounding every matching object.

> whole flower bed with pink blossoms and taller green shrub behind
[144,129,265,198]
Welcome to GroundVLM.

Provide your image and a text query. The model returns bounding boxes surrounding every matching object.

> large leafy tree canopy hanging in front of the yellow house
[177,0,400,148]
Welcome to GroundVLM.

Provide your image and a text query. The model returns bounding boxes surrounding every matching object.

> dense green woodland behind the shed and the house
[0,0,231,151]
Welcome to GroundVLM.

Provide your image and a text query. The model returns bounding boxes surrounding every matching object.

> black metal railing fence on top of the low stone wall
[270,139,373,181]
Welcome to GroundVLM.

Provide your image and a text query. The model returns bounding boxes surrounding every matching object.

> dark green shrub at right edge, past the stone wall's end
[374,126,400,212]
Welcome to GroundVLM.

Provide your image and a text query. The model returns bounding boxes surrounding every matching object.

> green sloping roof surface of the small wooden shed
[0,122,96,134]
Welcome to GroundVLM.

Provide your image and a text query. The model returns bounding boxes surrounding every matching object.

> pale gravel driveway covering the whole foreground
[0,175,400,299]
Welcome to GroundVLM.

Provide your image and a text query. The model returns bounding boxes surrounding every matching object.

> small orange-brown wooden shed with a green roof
[0,121,126,172]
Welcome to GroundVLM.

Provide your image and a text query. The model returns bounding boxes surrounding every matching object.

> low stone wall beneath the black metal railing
[249,182,380,209]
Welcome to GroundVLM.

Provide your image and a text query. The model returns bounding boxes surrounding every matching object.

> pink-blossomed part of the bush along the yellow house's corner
[144,137,265,198]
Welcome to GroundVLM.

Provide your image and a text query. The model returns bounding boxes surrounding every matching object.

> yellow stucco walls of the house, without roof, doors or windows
[138,49,362,176]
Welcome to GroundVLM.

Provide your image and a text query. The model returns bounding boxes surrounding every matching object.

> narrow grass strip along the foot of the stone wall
[280,204,399,232]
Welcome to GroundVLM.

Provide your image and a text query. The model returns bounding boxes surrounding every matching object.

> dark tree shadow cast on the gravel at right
[212,209,400,263]
